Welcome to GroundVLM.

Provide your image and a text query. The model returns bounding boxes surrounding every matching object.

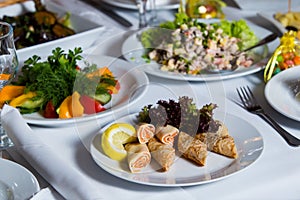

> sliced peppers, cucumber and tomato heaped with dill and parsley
[0,48,120,119]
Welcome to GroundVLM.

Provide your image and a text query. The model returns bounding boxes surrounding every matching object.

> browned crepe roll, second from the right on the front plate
[177,131,207,166]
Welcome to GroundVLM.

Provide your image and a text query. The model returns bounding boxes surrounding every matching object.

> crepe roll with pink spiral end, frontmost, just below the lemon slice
[125,142,151,173]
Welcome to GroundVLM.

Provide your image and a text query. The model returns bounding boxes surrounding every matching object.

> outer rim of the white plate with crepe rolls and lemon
[90,113,264,187]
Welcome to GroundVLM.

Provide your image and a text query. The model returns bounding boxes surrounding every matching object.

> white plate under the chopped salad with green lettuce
[122,24,279,81]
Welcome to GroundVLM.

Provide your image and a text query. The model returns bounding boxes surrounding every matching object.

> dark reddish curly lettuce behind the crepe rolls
[138,96,219,135]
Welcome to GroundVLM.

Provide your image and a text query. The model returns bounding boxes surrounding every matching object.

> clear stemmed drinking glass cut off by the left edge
[0,21,18,150]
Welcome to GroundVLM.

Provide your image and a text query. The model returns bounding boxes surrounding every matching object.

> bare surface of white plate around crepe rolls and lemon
[90,113,264,187]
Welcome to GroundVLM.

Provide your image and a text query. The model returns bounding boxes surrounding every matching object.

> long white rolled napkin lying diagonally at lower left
[1,105,103,200]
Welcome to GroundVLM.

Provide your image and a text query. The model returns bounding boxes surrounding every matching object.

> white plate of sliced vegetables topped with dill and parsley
[0,48,148,126]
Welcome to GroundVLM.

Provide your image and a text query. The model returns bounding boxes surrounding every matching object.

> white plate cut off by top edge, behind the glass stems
[102,0,179,10]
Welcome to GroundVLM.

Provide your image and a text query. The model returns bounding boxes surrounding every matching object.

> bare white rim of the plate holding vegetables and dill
[23,55,149,127]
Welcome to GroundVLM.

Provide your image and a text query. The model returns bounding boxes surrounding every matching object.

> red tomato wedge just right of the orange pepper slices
[80,95,105,114]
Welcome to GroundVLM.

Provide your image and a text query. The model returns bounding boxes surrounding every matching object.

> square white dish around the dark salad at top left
[0,1,104,61]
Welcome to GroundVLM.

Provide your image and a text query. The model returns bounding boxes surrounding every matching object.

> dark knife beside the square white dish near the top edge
[84,0,133,28]
